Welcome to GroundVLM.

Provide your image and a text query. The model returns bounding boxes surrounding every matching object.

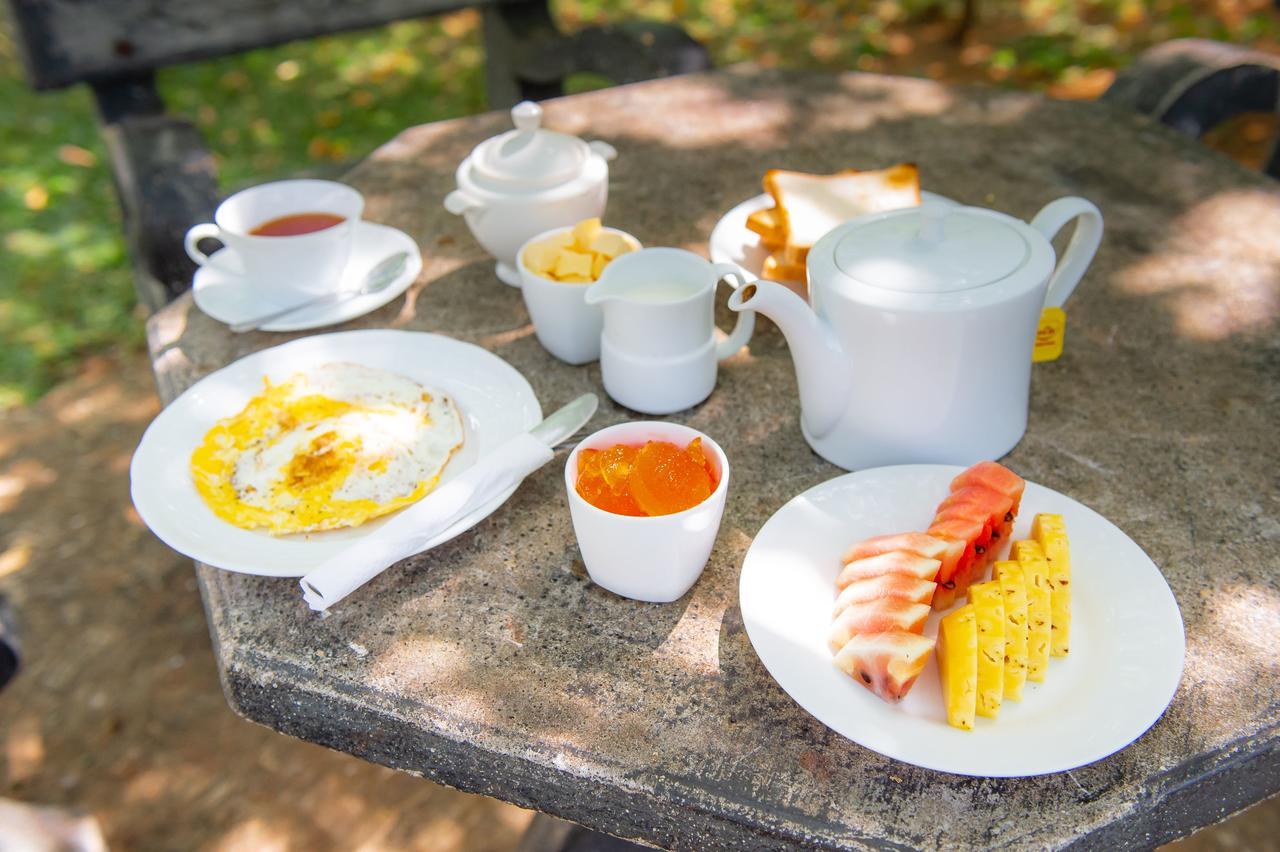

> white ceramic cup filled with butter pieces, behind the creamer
[516,228,640,365]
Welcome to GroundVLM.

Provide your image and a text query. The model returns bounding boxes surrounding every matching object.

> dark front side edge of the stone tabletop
[201,621,1280,849]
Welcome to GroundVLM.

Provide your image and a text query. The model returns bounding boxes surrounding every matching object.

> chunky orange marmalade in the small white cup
[575,438,718,517]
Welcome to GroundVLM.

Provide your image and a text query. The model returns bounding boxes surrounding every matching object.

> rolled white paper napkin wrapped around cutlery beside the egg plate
[301,432,554,611]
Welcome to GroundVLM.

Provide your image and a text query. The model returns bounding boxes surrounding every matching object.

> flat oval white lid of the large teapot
[835,202,1030,293]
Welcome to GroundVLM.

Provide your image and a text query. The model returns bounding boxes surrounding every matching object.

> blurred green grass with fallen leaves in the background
[0,0,1280,408]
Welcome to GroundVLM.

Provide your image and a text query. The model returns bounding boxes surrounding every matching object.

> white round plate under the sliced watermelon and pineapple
[739,464,1185,778]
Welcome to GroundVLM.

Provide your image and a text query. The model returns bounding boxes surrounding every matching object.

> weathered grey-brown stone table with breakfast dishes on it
[148,70,1280,849]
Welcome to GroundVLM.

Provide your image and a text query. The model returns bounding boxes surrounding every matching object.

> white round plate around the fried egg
[129,329,541,577]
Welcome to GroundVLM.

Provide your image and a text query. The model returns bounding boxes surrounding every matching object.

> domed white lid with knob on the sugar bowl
[470,101,590,192]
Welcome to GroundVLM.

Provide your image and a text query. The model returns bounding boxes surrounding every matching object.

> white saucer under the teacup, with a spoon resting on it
[192,221,422,331]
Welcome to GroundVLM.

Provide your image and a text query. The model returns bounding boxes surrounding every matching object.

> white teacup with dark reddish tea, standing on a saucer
[183,180,365,298]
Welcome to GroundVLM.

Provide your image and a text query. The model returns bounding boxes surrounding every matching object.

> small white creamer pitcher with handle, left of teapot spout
[586,248,755,414]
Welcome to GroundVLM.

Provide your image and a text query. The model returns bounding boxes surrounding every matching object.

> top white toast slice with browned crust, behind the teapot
[764,162,920,249]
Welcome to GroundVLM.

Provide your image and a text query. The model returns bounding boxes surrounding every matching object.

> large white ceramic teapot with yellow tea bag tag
[728,198,1102,471]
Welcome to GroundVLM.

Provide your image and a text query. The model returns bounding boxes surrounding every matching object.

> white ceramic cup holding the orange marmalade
[564,421,728,604]
